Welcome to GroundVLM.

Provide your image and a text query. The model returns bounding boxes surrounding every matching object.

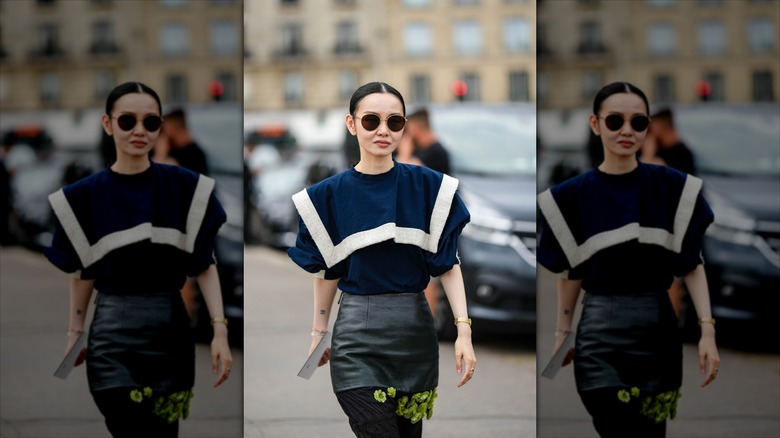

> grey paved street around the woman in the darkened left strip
[0,247,243,438]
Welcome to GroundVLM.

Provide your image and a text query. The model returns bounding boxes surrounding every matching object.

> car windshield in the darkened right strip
[675,107,780,176]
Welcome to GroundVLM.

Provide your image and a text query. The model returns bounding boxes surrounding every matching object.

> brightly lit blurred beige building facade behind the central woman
[244,0,536,111]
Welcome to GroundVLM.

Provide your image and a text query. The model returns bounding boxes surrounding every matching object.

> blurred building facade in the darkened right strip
[537,0,780,109]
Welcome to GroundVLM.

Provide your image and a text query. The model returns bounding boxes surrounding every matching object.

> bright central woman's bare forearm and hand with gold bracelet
[439,265,477,387]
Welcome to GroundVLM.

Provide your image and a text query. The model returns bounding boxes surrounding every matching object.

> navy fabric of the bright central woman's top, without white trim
[288,163,470,294]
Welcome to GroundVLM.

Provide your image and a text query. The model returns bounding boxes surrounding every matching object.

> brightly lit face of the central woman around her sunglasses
[347,93,404,158]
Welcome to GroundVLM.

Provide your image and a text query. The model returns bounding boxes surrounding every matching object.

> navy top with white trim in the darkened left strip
[45,163,226,294]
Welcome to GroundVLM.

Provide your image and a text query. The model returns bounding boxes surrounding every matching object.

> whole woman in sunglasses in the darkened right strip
[537,82,720,437]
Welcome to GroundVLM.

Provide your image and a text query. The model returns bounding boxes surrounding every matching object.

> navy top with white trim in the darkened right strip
[537,163,713,294]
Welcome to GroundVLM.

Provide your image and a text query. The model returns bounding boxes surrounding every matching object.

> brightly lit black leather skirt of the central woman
[330,292,439,393]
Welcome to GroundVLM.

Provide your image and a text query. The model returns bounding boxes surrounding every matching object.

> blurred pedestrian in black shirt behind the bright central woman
[397,108,450,316]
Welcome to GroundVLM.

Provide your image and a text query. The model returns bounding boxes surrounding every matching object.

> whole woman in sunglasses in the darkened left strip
[46,82,232,437]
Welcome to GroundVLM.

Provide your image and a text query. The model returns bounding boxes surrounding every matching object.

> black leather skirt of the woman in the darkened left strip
[87,291,195,393]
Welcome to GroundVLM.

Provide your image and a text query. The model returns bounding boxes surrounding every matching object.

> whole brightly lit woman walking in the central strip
[289,82,476,437]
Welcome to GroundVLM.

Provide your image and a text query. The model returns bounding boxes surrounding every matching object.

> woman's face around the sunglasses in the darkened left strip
[103,93,160,160]
